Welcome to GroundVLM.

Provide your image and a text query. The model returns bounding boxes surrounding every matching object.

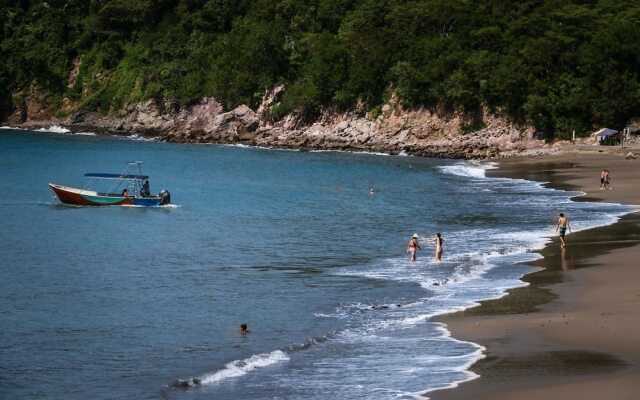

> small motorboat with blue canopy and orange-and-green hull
[49,161,171,207]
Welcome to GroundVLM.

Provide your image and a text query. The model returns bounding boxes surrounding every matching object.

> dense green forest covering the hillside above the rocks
[0,0,640,136]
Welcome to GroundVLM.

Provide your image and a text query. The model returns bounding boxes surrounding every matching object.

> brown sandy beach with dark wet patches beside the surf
[425,145,640,400]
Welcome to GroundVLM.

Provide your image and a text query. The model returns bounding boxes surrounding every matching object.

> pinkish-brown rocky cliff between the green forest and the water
[9,86,553,158]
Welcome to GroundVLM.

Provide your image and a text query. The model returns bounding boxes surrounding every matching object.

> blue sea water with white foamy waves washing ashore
[0,129,628,400]
